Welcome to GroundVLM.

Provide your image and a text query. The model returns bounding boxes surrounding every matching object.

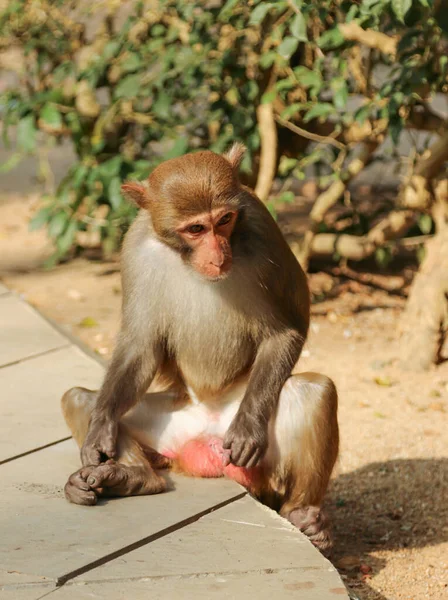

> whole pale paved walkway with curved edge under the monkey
[0,284,348,600]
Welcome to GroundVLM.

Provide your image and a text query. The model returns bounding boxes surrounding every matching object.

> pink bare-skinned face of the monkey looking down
[177,208,238,280]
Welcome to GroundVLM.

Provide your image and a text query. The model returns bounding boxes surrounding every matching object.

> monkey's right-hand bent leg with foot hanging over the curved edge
[259,373,339,552]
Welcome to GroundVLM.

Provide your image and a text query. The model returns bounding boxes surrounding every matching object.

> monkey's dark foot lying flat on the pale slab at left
[65,460,166,506]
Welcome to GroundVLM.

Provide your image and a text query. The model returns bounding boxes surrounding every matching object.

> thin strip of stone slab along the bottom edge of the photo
[51,572,348,600]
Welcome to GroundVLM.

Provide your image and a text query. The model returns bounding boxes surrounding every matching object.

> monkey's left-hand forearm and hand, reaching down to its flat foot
[81,333,161,466]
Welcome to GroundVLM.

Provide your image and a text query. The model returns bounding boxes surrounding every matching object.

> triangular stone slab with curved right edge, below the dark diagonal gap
[77,496,328,582]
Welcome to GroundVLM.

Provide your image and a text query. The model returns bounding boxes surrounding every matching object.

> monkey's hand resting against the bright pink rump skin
[222,413,268,468]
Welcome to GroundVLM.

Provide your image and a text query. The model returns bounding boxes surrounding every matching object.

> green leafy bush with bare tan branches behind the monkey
[0,0,448,264]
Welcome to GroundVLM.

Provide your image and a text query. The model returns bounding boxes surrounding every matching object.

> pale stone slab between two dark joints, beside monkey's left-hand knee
[0,346,104,463]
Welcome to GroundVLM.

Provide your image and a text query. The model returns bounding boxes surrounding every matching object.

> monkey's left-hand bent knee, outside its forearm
[61,387,98,446]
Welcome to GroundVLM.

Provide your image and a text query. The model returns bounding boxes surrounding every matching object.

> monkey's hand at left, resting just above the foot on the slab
[81,417,118,466]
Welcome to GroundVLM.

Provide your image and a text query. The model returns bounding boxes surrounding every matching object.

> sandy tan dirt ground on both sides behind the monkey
[0,195,448,600]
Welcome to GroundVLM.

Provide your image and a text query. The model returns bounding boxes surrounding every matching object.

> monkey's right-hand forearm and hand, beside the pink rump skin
[223,328,305,467]
